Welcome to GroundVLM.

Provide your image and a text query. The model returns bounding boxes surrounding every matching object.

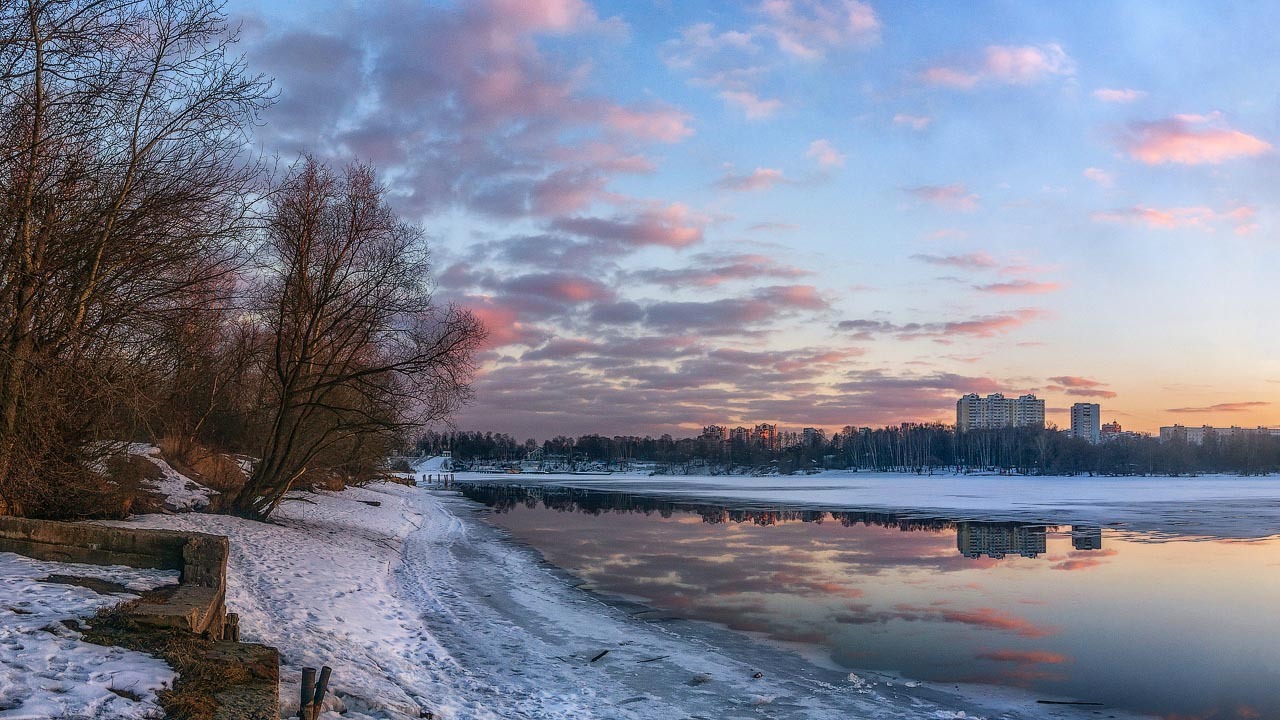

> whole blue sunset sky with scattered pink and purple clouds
[228,0,1280,439]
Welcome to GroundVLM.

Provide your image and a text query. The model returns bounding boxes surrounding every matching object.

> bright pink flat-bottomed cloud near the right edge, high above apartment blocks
[1121,113,1271,165]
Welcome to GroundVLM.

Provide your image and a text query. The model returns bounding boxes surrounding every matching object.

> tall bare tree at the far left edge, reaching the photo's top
[0,0,269,514]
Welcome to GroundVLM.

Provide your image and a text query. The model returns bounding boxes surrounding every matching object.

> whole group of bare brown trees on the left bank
[0,0,484,518]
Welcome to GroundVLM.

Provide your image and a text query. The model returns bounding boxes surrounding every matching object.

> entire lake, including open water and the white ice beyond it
[460,474,1280,719]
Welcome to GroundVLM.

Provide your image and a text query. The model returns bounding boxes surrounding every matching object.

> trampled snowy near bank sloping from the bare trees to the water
[127,484,1152,720]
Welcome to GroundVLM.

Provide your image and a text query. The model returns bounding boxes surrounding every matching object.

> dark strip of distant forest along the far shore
[416,423,1280,475]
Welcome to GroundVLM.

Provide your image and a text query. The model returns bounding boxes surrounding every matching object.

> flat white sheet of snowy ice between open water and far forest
[457,471,1280,538]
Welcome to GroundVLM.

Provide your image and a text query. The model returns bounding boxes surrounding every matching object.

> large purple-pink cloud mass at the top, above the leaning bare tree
[251,0,692,228]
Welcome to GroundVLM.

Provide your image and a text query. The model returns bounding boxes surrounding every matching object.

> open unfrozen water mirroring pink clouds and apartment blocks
[462,476,1280,719]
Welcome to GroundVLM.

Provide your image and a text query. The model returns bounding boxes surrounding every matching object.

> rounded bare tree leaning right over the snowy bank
[233,159,484,518]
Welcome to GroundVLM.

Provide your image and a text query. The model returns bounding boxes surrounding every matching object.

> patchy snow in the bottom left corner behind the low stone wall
[0,552,177,720]
